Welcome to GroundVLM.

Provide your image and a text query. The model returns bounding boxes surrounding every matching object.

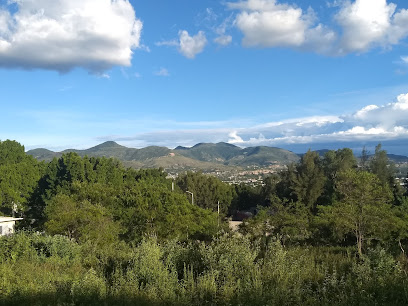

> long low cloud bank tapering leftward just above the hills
[104,93,408,154]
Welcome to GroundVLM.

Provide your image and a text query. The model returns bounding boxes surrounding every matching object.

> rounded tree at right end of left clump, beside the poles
[118,179,217,241]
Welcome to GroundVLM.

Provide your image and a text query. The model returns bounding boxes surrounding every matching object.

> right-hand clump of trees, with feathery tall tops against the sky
[237,145,408,256]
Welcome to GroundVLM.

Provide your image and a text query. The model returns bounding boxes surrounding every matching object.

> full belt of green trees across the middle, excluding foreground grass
[0,140,408,255]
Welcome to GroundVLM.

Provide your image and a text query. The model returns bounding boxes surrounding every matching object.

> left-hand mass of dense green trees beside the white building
[0,141,220,244]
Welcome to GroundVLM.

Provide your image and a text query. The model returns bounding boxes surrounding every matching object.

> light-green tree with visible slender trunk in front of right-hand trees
[320,170,394,256]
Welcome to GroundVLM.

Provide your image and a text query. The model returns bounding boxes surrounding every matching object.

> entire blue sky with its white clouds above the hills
[0,0,408,154]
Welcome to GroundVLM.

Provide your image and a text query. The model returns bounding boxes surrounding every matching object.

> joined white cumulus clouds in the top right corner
[228,0,408,55]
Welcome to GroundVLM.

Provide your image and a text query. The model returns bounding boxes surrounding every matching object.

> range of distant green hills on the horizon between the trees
[27,141,299,170]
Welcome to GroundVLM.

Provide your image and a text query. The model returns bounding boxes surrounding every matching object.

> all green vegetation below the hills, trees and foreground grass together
[0,140,408,305]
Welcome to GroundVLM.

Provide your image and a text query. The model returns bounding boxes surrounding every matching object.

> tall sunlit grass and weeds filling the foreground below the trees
[0,232,408,305]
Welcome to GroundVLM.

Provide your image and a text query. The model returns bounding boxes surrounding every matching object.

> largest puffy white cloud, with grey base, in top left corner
[0,0,143,73]
